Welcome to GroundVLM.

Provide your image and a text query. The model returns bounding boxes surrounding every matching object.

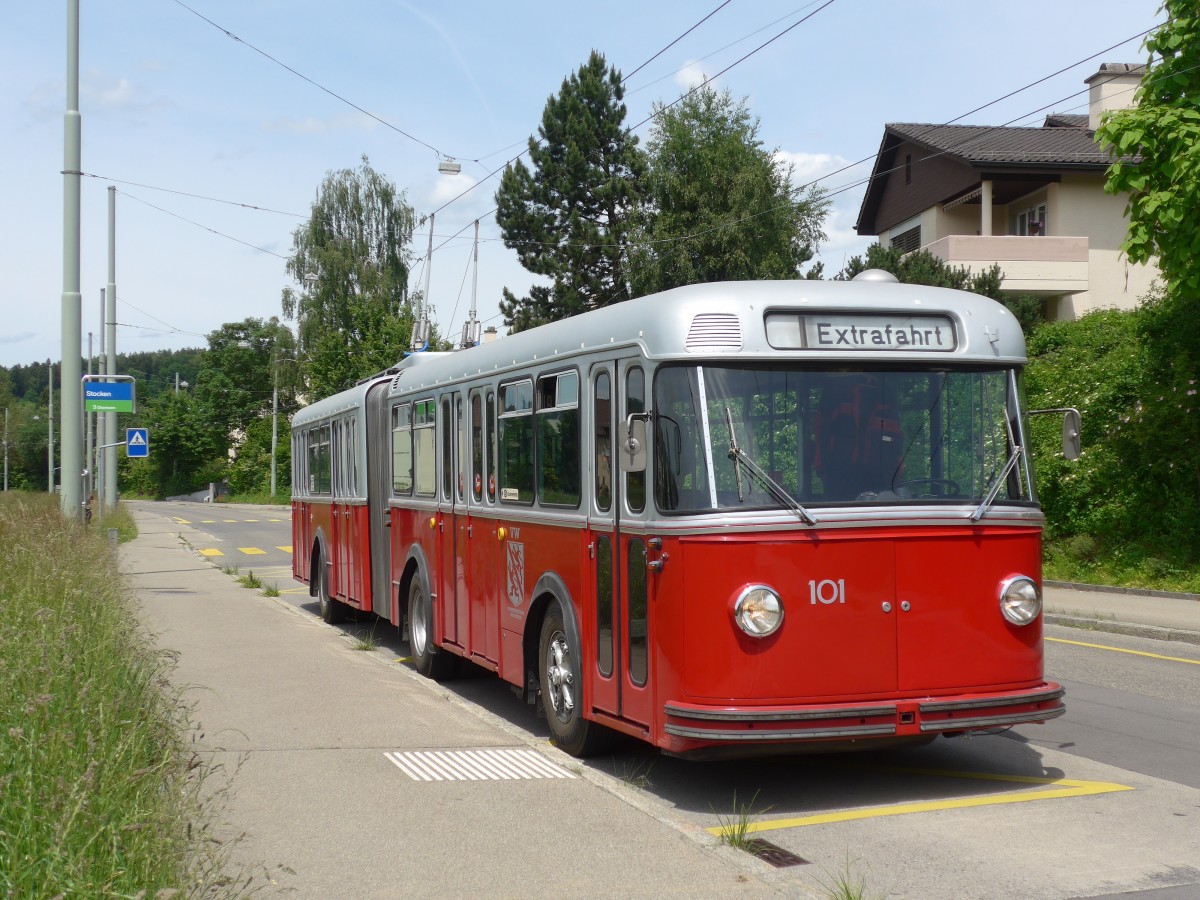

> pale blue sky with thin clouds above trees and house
[0,0,1162,365]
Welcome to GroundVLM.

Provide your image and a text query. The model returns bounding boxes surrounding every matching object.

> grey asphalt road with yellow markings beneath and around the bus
[131,504,1200,900]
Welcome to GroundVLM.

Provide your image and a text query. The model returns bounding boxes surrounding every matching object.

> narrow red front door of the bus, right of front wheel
[581,359,653,726]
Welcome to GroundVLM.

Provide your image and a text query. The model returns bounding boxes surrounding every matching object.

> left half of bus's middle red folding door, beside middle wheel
[434,392,469,647]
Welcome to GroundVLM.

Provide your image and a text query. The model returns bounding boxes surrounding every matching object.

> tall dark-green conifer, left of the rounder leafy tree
[496,50,646,329]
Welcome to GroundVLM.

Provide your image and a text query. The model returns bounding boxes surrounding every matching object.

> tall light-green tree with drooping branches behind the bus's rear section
[283,156,415,400]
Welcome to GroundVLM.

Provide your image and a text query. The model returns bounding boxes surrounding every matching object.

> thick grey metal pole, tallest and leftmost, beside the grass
[59,0,83,520]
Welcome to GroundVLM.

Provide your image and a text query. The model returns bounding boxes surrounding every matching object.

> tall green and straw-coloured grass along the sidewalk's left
[0,492,226,898]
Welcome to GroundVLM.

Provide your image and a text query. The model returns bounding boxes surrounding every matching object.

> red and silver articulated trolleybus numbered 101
[292,272,1078,755]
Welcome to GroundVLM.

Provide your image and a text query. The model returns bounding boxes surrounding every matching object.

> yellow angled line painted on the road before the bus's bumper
[706,766,1134,836]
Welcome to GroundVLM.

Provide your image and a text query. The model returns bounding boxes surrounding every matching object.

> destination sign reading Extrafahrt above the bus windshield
[767,313,958,353]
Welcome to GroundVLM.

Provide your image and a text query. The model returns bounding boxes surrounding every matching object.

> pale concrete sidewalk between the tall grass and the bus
[120,510,818,900]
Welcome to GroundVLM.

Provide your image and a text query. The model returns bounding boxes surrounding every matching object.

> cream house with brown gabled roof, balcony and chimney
[856,62,1158,319]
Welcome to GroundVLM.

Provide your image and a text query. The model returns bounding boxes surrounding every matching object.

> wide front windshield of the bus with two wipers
[654,366,1033,512]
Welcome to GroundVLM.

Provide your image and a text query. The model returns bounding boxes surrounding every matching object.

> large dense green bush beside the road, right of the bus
[1026,296,1200,587]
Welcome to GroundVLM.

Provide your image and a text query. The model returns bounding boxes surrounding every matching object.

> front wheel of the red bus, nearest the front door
[538,604,611,756]
